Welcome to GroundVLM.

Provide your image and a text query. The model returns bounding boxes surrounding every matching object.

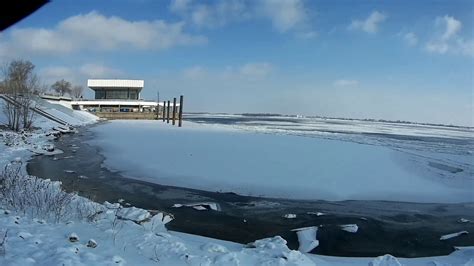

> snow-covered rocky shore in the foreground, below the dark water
[0,104,474,265]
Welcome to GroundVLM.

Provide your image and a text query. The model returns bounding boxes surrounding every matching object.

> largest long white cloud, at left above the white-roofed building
[0,12,207,54]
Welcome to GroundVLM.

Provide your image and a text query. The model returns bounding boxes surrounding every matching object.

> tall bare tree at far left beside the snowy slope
[2,60,40,131]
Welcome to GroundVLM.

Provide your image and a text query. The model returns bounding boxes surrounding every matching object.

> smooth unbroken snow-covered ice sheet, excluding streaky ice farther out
[92,121,474,202]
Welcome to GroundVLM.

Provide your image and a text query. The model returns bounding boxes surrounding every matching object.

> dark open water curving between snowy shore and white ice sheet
[27,128,474,257]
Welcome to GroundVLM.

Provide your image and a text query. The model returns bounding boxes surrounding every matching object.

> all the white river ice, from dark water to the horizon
[86,115,474,203]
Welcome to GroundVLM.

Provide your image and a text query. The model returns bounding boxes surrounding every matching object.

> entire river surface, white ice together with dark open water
[28,116,474,257]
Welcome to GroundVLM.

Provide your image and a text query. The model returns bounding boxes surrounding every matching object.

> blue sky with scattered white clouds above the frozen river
[0,0,474,126]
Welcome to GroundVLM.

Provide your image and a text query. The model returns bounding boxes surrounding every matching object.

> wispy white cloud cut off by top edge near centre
[170,0,315,34]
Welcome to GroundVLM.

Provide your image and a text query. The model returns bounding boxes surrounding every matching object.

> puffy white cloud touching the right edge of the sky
[425,15,474,57]
